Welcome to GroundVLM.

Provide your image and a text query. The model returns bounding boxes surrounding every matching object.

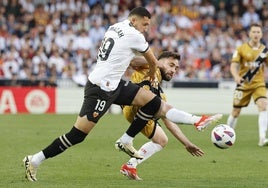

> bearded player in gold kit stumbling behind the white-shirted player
[120,51,204,180]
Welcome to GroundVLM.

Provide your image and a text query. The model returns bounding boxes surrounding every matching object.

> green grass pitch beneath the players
[0,114,268,188]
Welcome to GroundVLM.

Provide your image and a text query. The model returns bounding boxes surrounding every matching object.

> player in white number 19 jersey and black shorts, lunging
[23,7,222,181]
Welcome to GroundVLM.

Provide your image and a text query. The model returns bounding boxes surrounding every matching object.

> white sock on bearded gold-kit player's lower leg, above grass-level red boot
[127,141,163,168]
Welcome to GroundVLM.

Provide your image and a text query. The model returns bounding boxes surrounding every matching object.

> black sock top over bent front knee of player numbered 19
[137,96,161,120]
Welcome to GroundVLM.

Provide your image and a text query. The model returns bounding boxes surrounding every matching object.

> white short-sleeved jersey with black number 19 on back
[88,20,149,91]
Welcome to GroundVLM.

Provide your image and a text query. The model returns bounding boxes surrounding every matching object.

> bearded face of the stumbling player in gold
[159,57,179,81]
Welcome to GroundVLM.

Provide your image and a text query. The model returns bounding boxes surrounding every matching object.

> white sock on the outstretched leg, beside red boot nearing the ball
[166,108,201,125]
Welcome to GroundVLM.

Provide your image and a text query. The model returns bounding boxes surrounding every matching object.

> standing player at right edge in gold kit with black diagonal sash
[227,24,268,146]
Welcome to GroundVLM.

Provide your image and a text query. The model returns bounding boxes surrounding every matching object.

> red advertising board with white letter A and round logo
[0,87,55,114]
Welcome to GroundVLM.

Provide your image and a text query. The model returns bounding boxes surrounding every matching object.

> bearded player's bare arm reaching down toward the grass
[162,118,204,157]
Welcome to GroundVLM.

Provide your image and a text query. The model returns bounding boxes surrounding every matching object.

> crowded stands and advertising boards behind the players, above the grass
[0,0,268,113]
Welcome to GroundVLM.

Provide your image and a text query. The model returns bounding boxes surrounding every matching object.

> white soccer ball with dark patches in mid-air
[211,124,236,149]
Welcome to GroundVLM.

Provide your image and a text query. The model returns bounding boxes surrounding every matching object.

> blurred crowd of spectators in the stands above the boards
[0,0,268,87]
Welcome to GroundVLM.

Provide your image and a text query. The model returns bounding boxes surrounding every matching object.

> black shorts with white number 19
[79,80,140,123]
